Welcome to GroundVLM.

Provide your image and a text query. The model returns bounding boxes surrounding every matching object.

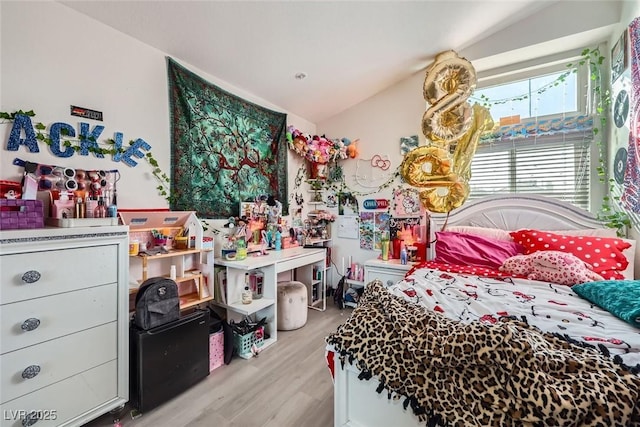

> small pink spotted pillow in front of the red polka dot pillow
[500,251,604,286]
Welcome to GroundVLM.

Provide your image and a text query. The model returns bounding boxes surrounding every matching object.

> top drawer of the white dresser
[0,245,118,304]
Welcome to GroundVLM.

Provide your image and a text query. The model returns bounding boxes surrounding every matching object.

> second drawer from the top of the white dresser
[0,283,118,354]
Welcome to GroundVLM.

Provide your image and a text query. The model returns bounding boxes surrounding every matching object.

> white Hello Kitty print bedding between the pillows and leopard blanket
[389,268,640,367]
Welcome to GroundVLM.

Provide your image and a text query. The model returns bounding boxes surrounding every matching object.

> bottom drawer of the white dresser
[0,360,118,427]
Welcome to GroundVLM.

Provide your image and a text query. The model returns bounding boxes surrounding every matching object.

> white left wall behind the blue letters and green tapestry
[0,1,315,234]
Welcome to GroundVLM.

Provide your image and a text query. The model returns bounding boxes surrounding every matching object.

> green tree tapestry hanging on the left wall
[167,58,288,218]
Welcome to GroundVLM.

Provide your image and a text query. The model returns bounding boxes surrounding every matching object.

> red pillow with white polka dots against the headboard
[509,230,631,279]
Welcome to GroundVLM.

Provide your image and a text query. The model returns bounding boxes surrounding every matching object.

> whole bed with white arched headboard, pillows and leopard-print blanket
[327,194,640,427]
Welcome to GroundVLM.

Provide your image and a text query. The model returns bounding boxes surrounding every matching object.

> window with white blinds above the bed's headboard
[469,61,593,209]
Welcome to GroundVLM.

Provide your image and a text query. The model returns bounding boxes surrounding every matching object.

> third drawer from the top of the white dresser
[0,322,118,409]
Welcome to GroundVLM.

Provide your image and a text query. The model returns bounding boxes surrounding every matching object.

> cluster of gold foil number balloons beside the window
[400,51,493,213]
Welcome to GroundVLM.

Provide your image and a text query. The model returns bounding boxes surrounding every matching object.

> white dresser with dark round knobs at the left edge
[0,226,129,427]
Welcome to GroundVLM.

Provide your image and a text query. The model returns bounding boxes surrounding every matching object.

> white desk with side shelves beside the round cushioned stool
[215,247,326,356]
